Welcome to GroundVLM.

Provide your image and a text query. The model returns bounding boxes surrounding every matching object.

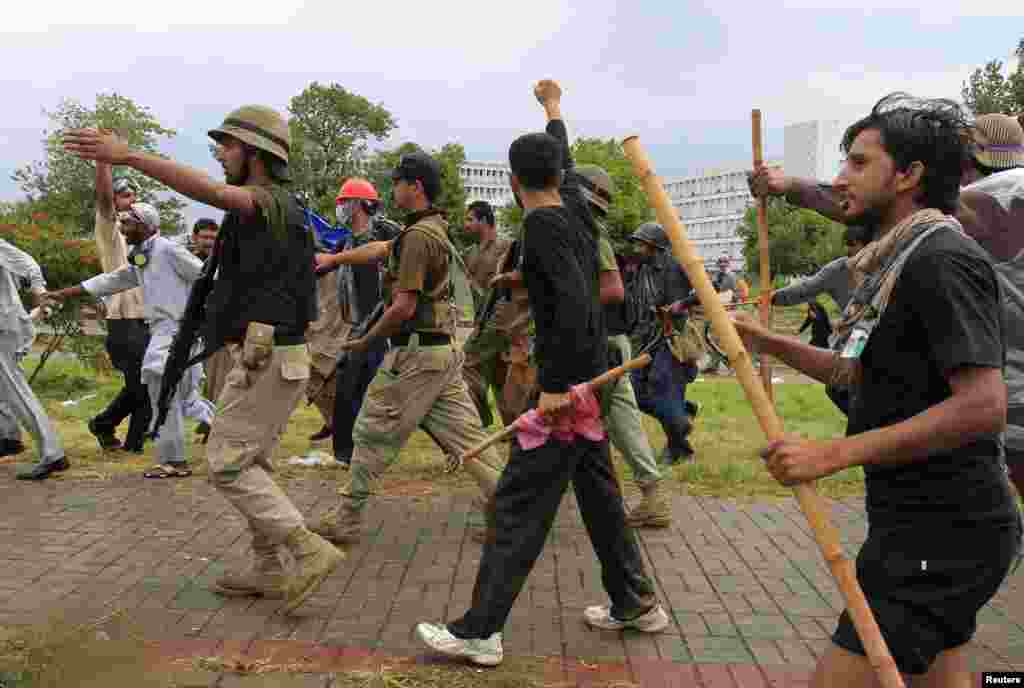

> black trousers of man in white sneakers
[447,438,655,638]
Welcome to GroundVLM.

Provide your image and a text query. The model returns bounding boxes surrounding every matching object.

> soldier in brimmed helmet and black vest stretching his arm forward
[65,105,344,612]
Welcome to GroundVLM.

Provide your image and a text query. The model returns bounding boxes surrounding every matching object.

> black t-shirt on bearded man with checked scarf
[847,229,1017,536]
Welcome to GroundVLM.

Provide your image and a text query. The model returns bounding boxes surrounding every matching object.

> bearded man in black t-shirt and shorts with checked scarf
[736,95,1021,688]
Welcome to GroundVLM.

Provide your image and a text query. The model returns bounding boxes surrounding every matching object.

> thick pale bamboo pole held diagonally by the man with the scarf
[623,136,904,688]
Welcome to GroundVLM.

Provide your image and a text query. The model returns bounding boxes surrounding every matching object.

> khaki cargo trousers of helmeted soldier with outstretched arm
[207,344,309,545]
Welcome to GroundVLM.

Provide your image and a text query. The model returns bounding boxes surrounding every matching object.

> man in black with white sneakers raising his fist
[417,133,669,665]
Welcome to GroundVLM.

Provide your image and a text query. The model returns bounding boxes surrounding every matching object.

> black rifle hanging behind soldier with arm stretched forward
[150,243,220,438]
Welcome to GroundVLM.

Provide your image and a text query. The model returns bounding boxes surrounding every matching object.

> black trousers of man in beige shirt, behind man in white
[93,319,153,449]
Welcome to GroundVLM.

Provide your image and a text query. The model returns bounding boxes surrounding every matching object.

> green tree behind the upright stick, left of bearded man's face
[737,199,846,275]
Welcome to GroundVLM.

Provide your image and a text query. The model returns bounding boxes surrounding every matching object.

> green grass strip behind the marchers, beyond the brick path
[19,350,863,498]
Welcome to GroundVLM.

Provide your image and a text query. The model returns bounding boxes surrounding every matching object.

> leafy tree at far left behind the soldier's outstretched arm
[12,93,185,237]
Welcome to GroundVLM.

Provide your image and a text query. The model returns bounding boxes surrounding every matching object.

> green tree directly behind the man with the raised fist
[499,138,654,245]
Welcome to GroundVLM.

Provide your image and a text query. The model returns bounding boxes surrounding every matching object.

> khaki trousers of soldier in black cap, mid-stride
[342,335,501,511]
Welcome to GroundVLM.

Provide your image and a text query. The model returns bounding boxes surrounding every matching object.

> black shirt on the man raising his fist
[521,206,607,393]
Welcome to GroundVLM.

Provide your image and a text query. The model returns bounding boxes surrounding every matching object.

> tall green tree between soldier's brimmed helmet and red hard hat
[288,81,396,216]
